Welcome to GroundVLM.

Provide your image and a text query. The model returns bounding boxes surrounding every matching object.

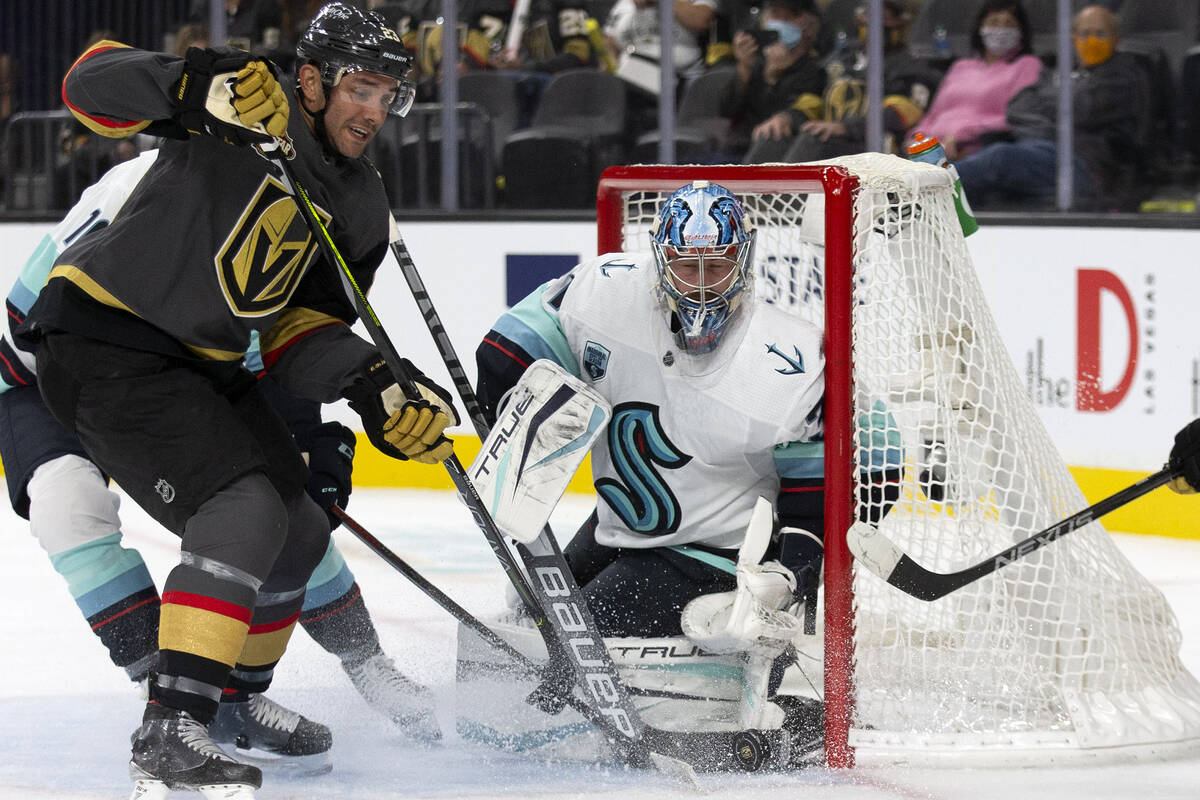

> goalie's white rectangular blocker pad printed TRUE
[468,359,612,543]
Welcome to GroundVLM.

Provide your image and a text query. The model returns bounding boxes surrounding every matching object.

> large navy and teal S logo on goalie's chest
[596,403,691,534]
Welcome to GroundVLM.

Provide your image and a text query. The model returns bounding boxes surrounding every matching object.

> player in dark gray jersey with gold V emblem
[18,2,456,798]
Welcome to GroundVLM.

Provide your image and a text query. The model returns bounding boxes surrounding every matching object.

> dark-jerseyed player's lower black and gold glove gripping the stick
[343,355,458,464]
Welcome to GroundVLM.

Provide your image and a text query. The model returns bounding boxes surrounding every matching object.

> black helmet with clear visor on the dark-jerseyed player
[296,2,416,116]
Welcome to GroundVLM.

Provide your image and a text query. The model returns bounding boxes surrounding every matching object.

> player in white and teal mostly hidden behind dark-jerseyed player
[0,150,438,772]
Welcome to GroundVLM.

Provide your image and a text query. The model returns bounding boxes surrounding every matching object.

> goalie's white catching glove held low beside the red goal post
[679,498,804,657]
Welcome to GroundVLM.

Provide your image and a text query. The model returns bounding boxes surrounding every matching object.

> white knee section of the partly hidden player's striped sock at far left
[26,456,121,555]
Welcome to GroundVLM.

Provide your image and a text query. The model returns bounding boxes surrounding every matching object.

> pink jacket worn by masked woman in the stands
[914,55,1042,156]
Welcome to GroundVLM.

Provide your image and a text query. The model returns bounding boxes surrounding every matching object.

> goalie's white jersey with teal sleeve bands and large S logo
[481,253,824,548]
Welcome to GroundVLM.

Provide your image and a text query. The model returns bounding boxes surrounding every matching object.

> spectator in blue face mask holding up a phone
[720,0,826,163]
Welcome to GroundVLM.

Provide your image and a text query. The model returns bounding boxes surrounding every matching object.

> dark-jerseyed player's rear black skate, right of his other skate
[209,694,334,775]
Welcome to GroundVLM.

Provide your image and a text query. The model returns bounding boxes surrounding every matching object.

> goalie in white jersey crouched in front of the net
[476,181,844,637]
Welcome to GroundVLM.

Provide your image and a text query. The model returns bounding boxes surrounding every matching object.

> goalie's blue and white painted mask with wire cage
[650,181,754,355]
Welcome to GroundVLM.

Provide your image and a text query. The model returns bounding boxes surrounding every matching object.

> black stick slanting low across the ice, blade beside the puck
[332,505,811,771]
